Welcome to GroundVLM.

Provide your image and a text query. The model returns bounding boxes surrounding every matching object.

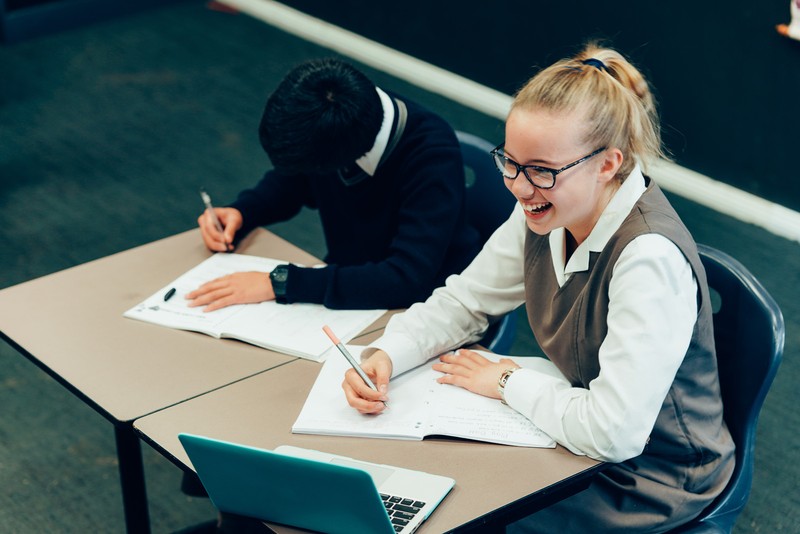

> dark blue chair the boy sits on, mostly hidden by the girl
[456,132,516,354]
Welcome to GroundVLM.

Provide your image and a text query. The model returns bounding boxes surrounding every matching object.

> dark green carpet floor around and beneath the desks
[0,2,800,533]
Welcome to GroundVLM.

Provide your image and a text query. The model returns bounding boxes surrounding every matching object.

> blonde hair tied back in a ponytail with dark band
[511,42,666,181]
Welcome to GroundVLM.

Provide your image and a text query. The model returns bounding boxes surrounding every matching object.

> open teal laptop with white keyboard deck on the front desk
[178,434,455,534]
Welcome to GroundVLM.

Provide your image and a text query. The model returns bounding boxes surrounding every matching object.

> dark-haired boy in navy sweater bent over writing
[188,59,478,310]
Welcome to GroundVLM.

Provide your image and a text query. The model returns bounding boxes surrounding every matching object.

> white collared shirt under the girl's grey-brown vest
[362,167,697,462]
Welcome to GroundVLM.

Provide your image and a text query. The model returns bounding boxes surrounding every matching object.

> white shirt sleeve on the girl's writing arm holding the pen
[368,204,527,376]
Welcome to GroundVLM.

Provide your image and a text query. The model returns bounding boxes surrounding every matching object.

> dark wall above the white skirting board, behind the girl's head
[283,0,800,214]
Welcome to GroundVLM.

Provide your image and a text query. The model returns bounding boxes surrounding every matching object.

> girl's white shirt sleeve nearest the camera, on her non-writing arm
[505,234,697,462]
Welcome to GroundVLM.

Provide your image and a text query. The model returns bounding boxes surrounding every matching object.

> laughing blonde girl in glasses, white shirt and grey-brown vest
[343,44,734,533]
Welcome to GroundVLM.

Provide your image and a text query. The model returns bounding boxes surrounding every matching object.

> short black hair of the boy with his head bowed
[258,58,383,174]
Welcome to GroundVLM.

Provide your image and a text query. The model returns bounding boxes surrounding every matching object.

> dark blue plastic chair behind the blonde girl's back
[674,245,786,534]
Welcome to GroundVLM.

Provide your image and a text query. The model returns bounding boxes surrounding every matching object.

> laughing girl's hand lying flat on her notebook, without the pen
[433,349,519,399]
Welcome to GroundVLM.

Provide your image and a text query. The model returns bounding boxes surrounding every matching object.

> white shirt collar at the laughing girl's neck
[549,165,647,285]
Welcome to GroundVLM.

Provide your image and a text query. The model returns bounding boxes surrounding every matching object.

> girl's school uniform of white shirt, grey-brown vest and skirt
[365,167,734,532]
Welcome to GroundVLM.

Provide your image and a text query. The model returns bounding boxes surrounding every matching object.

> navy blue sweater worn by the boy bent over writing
[231,96,480,309]
